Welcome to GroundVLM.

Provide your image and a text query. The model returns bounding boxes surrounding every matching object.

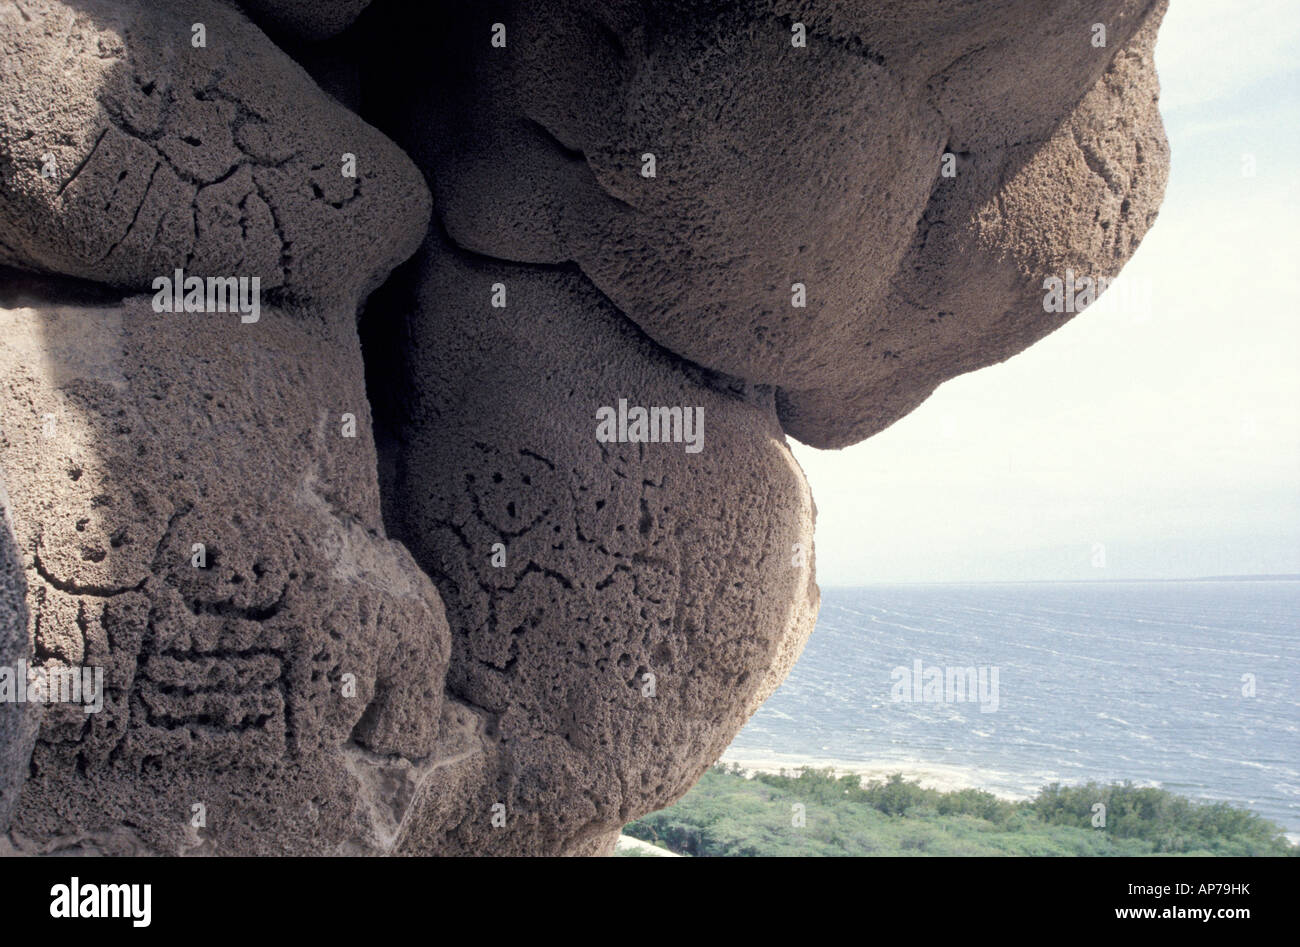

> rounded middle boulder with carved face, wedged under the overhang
[368,236,818,853]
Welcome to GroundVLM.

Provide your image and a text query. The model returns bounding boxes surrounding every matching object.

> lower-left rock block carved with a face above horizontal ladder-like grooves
[0,295,450,853]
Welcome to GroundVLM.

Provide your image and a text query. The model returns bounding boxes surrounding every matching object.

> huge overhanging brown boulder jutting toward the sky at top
[377,0,1167,446]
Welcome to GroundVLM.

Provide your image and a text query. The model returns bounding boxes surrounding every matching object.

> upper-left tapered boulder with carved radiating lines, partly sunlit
[0,0,429,303]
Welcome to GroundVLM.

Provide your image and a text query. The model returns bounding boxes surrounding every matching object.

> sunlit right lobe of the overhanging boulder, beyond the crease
[779,4,1169,446]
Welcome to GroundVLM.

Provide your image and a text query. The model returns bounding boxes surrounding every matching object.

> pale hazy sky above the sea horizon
[794,0,1300,585]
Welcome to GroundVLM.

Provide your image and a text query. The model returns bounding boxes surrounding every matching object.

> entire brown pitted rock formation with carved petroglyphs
[0,0,1167,855]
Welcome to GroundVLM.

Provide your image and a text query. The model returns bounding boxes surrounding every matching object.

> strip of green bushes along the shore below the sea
[624,765,1296,856]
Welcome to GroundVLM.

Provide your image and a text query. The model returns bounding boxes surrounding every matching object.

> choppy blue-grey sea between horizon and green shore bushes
[724,581,1300,834]
